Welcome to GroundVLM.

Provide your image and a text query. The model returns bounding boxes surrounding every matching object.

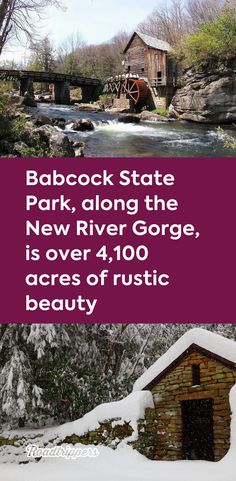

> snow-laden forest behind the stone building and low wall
[0,324,236,428]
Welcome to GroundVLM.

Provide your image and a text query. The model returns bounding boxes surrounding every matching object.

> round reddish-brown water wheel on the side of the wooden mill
[104,75,150,111]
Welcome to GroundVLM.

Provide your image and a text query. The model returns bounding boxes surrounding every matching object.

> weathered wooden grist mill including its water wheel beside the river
[104,32,178,111]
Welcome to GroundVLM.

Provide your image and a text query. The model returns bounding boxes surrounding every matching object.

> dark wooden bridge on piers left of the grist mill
[0,69,103,104]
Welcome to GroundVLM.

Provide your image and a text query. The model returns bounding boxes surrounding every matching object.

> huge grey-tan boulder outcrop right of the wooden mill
[170,61,236,124]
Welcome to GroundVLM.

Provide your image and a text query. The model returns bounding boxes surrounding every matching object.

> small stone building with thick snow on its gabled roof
[134,329,236,461]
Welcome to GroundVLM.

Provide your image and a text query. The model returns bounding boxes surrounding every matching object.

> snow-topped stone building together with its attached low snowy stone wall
[0,329,236,464]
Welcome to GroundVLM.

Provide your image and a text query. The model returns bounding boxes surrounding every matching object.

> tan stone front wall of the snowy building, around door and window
[152,352,236,461]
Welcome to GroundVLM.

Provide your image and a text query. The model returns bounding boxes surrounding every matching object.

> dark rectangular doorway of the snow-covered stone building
[181,399,214,461]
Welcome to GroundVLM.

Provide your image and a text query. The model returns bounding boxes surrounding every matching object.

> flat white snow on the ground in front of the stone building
[0,446,236,481]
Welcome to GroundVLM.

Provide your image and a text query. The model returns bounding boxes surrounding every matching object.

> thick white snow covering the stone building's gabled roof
[133,328,236,391]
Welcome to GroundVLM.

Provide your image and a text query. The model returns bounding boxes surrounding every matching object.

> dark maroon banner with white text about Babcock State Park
[0,158,236,323]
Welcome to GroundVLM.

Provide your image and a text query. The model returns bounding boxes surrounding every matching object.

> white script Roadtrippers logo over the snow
[26,444,100,459]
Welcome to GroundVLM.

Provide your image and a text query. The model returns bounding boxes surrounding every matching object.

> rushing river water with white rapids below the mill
[34,104,235,157]
